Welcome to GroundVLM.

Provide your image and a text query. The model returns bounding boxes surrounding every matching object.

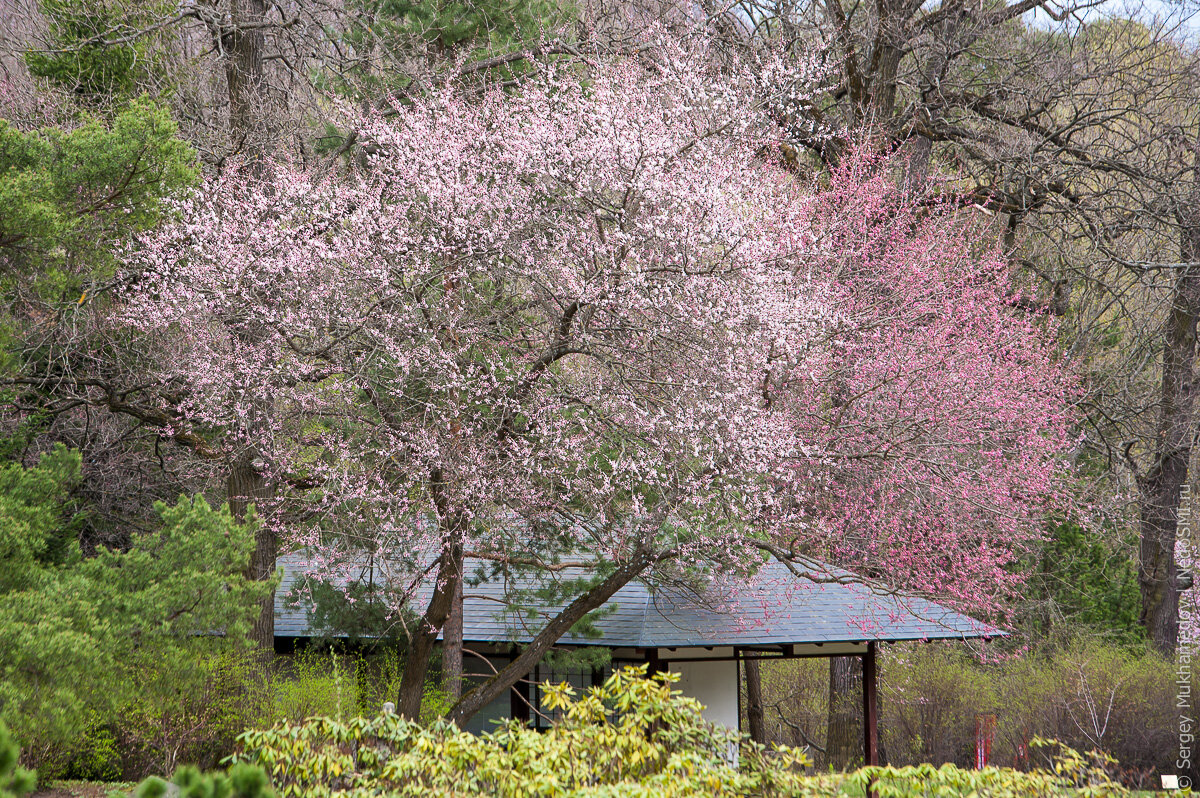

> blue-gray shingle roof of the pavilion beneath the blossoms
[275,554,1006,648]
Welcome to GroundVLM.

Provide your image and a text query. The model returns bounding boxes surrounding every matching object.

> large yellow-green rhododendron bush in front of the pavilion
[234,667,816,797]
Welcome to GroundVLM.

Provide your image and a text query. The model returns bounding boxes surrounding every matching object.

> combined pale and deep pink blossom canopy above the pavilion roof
[112,35,1069,624]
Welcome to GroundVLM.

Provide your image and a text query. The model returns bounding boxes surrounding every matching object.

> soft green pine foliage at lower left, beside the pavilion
[0,446,274,772]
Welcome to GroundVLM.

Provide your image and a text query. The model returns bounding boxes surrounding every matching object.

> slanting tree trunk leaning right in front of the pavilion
[446,550,655,726]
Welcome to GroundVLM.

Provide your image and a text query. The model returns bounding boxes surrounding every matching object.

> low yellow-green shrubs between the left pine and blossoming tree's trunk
[22,637,436,781]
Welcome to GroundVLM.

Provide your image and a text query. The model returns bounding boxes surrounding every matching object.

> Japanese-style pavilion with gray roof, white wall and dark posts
[275,554,1007,763]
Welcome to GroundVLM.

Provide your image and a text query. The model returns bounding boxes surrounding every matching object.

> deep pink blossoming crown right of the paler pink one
[774,156,1078,612]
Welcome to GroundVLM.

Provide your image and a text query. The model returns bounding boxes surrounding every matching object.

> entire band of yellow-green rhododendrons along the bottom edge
[154,667,1128,798]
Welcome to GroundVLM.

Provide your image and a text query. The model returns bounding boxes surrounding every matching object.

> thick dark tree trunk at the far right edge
[1138,162,1200,655]
